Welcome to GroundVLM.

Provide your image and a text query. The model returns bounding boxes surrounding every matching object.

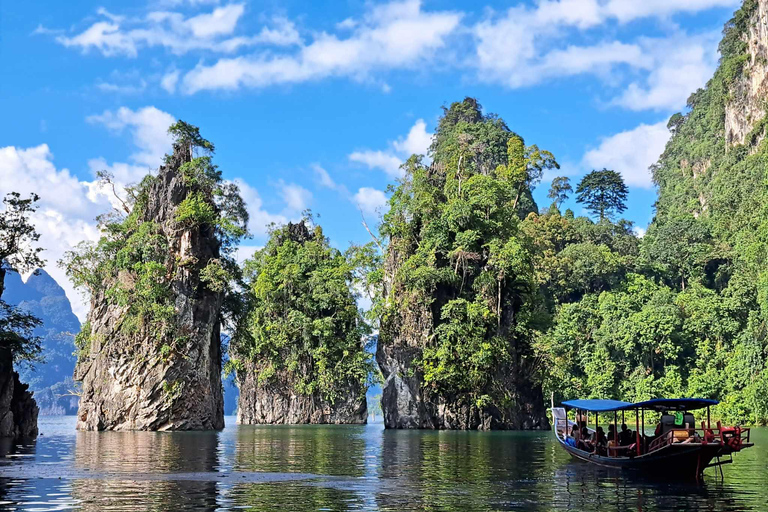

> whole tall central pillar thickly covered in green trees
[377,98,557,428]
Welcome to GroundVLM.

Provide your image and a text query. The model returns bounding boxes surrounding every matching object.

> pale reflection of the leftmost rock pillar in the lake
[72,432,218,511]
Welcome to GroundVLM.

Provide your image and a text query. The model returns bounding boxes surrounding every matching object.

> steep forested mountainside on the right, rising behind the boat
[537,0,768,424]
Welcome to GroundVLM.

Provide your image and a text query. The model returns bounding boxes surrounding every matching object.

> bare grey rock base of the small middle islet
[237,369,368,425]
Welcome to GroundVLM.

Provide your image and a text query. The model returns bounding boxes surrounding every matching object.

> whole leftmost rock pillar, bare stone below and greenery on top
[62,121,247,430]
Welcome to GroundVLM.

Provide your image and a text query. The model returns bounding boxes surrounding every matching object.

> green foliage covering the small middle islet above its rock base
[228,217,373,403]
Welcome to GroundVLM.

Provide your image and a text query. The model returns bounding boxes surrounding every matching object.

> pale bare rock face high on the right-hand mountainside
[725,0,768,145]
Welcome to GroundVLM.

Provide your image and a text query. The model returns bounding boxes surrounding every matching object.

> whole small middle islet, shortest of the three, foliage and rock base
[227,218,372,424]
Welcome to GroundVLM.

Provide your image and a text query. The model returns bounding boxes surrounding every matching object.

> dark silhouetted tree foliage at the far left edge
[0,192,44,361]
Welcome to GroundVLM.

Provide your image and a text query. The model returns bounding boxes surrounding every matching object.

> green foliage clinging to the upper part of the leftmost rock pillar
[60,121,248,357]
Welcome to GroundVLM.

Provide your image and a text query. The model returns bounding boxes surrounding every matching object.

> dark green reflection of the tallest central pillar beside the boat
[376,431,549,511]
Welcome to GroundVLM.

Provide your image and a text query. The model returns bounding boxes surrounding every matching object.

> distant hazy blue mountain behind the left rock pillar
[3,270,80,415]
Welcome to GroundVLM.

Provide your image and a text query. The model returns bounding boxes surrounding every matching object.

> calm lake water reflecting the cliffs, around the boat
[0,417,768,511]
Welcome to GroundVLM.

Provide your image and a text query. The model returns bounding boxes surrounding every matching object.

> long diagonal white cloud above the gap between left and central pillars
[183,0,461,94]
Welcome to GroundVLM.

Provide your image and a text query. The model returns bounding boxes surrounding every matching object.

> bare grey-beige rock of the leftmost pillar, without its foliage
[75,147,224,430]
